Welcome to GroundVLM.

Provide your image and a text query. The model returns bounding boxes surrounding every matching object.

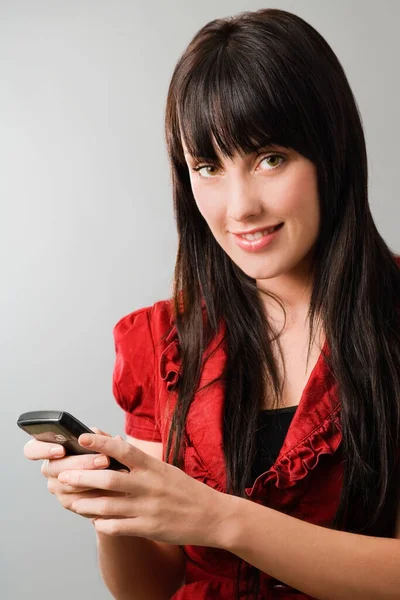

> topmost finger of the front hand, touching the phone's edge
[78,433,148,469]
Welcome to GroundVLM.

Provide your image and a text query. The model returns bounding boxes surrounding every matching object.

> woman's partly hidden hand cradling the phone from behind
[24,427,122,519]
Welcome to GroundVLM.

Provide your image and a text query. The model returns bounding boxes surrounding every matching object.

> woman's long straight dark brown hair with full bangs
[165,9,400,597]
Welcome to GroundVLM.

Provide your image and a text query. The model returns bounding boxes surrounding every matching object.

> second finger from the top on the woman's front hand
[58,470,132,493]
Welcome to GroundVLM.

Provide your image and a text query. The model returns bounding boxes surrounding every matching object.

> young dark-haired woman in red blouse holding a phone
[25,9,400,600]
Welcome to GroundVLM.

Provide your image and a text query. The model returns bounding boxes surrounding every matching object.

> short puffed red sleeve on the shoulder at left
[112,307,162,442]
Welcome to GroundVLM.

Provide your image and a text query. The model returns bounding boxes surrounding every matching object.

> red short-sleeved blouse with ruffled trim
[113,300,342,600]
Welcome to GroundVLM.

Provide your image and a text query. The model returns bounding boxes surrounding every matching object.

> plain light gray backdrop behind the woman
[0,0,400,600]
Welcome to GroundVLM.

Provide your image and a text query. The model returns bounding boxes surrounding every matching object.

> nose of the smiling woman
[227,177,263,222]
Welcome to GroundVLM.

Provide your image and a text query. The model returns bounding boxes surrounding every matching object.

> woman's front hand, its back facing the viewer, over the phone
[58,434,234,548]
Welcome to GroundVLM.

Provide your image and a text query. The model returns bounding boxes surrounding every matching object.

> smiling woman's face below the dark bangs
[183,141,320,288]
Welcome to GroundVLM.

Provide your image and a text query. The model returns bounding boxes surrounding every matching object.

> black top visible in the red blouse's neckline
[252,406,297,483]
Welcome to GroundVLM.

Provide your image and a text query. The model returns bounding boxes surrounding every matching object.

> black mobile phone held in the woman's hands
[17,410,130,471]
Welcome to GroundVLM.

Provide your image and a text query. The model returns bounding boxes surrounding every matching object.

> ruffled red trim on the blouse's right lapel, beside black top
[246,406,342,494]
